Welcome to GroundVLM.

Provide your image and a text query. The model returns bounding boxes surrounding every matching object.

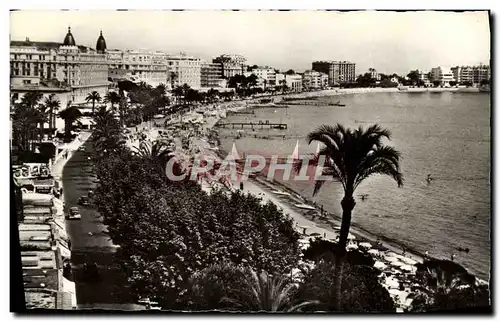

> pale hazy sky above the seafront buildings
[10,10,490,74]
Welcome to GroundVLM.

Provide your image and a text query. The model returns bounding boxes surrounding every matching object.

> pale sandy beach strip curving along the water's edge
[126,88,488,310]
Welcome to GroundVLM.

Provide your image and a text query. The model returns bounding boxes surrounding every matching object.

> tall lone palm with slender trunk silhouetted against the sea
[295,124,403,310]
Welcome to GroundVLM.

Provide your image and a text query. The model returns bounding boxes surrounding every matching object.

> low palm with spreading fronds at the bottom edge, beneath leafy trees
[222,268,318,312]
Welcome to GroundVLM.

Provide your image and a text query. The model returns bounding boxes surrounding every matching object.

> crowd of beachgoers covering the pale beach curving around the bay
[122,88,488,309]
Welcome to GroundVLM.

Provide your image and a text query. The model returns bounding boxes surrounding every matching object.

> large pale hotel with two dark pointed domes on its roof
[10,27,110,123]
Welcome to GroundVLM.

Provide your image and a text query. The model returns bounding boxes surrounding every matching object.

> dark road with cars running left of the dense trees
[62,138,141,310]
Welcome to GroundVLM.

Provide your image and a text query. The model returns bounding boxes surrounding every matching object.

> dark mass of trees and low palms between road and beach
[92,109,418,312]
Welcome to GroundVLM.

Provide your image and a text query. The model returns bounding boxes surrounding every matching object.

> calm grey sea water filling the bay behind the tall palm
[221,92,490,279]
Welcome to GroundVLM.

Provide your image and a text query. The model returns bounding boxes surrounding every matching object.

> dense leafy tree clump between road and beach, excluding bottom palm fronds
[93,111,300,309]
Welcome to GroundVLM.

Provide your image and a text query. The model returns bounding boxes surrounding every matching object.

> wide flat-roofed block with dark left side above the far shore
[312,61,356,86]
